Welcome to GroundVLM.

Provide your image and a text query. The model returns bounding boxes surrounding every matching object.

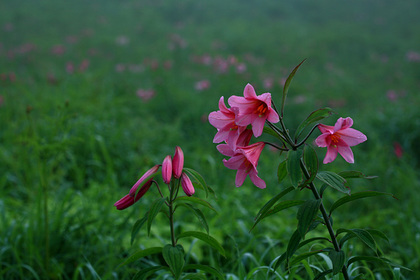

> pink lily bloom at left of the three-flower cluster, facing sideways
[209,96,246,147]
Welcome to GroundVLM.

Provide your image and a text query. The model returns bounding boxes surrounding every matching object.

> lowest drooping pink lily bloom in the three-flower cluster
[223,142,266,189]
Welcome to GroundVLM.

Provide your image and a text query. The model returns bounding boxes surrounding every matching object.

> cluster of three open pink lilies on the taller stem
[209,84,279,188]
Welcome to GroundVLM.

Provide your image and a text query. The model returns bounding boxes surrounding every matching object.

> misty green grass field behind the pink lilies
[0,0,420,279]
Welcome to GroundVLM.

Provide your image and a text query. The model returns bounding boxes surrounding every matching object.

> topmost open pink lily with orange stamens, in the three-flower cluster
[228,84,279,137]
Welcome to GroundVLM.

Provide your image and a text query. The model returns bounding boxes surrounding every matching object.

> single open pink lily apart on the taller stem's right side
[315,118,367,164]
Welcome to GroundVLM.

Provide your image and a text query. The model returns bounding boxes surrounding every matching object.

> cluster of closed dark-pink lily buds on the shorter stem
[114,147,195,210]
